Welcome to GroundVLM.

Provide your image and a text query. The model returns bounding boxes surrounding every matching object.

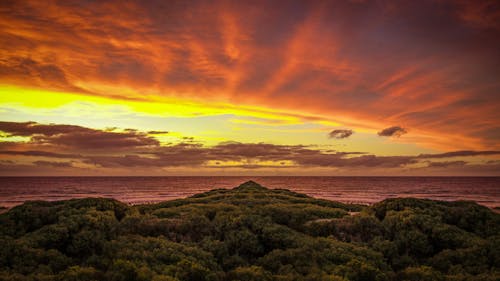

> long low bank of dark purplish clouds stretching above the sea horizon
[0,122,500,171]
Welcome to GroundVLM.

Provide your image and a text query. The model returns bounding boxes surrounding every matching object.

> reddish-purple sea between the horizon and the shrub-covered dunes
[0,177,500,207]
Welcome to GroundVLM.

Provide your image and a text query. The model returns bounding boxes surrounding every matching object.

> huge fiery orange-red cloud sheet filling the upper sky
[0,0,500,149]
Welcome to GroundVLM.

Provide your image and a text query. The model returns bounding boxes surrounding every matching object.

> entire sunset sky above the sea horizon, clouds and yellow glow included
[0,0,500,176]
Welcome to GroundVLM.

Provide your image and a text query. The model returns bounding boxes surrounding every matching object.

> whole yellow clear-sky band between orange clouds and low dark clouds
[0,82,450,155]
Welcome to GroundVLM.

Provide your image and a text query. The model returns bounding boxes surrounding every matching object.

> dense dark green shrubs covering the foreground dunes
[0,182,500,281]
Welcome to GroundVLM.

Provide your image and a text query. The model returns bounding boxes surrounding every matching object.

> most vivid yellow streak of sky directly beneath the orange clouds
[0,85,339,126]
